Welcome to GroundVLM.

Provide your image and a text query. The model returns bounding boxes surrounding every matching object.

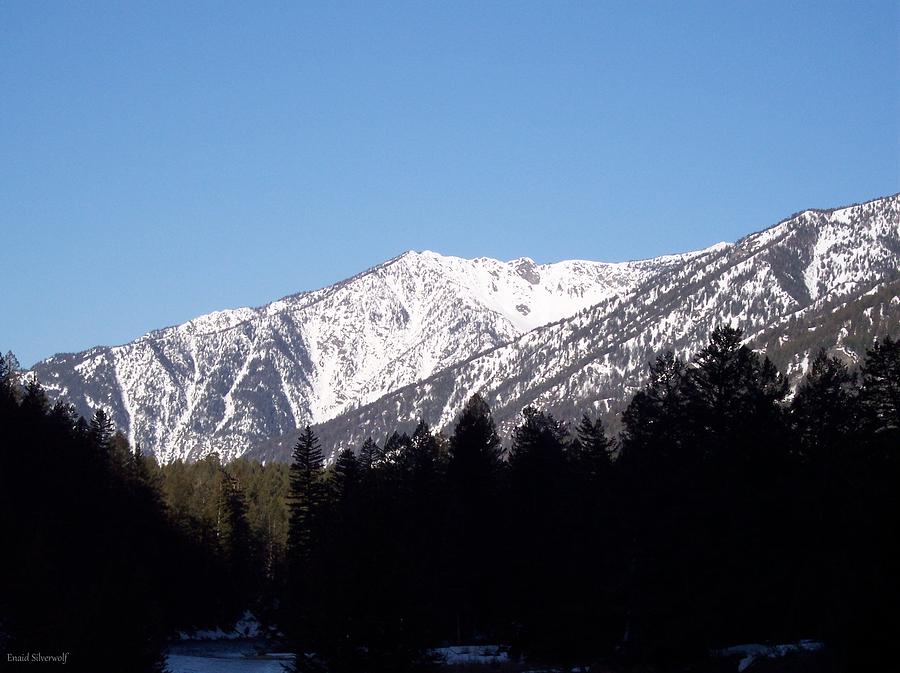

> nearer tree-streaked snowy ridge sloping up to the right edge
[255,195,900,458]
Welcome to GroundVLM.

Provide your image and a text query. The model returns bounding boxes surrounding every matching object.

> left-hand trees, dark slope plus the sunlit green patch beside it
[0,355,287,673]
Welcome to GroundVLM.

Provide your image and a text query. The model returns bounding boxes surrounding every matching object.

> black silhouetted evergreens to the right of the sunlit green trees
[281,328,900,672]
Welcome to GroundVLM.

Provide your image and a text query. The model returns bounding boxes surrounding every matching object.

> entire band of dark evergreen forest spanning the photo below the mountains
[0,328,900,673]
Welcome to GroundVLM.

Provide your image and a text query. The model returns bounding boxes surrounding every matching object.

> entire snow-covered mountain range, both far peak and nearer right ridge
[33,190,900,460]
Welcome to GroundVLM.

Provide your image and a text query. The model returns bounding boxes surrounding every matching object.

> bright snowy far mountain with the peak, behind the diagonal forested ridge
[26,252,690,461]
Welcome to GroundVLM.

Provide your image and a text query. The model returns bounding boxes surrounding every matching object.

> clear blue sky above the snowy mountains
[0,0,900,365]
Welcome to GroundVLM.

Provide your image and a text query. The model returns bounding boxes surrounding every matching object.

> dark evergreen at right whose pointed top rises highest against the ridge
[676,327,796,648]
